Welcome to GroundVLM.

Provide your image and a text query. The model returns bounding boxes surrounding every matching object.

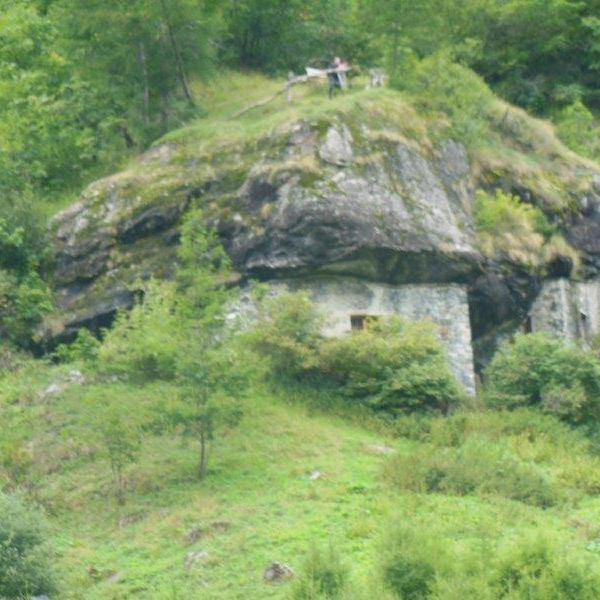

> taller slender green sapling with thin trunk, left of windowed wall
[168,211,248,479]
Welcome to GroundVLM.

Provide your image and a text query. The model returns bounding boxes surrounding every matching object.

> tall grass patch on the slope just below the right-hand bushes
[384,407,600,507]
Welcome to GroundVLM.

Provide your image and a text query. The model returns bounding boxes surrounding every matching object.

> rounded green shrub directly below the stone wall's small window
[318,317,462,414]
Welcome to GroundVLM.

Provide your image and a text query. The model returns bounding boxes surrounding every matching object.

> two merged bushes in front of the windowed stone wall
[249,292,463,415]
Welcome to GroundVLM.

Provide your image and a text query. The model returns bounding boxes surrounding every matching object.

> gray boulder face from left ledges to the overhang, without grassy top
[49,122,481,338]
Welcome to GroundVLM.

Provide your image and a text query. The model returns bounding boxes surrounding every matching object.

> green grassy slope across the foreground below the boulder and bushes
[0,354,600,600]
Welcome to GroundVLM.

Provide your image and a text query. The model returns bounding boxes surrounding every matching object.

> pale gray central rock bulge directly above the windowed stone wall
[228,132,481,283]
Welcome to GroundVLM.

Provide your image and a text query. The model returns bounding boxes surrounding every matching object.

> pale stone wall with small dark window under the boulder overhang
[274,278,475,394]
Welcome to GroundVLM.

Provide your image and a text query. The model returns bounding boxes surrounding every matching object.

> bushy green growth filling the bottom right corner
[377,519,600,600]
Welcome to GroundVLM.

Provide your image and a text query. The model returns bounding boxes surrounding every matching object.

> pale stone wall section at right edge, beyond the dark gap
[529,279,600,342]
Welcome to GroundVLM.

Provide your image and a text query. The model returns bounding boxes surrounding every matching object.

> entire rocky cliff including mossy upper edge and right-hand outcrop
[47,92,600,372]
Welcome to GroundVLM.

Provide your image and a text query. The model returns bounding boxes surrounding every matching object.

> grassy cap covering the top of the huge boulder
[81,63,592,234]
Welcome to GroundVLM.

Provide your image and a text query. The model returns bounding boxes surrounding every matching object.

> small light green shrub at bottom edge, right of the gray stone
[293,544,349,600]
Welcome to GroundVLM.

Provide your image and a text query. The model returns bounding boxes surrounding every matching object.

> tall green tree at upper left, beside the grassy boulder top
[50,0,218,144]
